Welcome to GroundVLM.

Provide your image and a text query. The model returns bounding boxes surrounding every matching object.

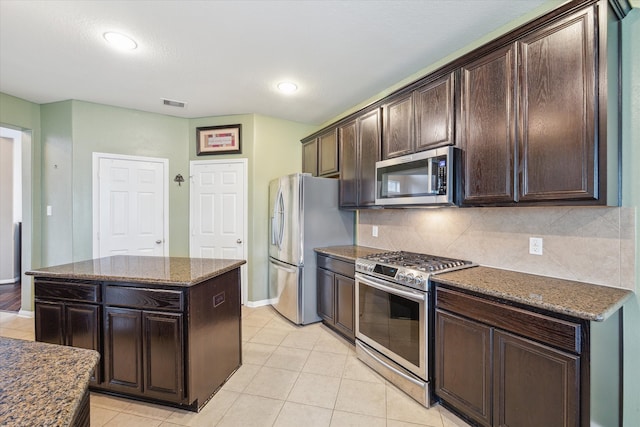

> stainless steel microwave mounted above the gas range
[376,146,456,206]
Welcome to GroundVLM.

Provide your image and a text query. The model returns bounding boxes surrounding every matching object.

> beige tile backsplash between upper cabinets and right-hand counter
[357,207,636,290]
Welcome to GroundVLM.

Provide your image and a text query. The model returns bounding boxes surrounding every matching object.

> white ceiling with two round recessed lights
[0,0,562,124]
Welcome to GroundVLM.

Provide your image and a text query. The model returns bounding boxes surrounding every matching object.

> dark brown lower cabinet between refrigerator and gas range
[316,254,356,342]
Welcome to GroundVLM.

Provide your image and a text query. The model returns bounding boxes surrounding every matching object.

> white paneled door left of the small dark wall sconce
[94,153,169,257]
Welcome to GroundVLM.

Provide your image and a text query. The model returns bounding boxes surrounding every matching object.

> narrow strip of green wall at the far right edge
[622,9,640,426]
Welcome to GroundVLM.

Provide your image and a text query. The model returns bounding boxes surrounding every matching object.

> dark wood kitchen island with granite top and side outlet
[27,255,245,411]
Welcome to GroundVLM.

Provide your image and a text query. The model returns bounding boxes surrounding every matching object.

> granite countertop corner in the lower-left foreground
[0,337,100,426]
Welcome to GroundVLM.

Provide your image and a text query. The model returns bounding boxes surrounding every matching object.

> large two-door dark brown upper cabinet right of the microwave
[460,6,606,205]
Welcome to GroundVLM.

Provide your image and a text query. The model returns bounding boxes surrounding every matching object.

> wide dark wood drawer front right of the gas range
[436,287,582,354]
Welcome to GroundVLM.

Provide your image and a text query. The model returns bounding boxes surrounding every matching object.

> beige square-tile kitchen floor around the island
[0,307,467,427]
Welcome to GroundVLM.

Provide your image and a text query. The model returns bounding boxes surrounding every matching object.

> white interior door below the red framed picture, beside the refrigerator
[189,159,247,302]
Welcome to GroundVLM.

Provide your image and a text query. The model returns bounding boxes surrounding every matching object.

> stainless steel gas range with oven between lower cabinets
[356,251,475,407]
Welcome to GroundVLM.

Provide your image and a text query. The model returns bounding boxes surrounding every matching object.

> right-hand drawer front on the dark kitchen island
[104,285,184,311]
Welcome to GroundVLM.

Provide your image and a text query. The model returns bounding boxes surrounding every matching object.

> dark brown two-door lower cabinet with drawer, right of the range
[434,287,589,427]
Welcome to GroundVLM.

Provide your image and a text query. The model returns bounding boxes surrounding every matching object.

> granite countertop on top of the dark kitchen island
[26,255,246,286]
